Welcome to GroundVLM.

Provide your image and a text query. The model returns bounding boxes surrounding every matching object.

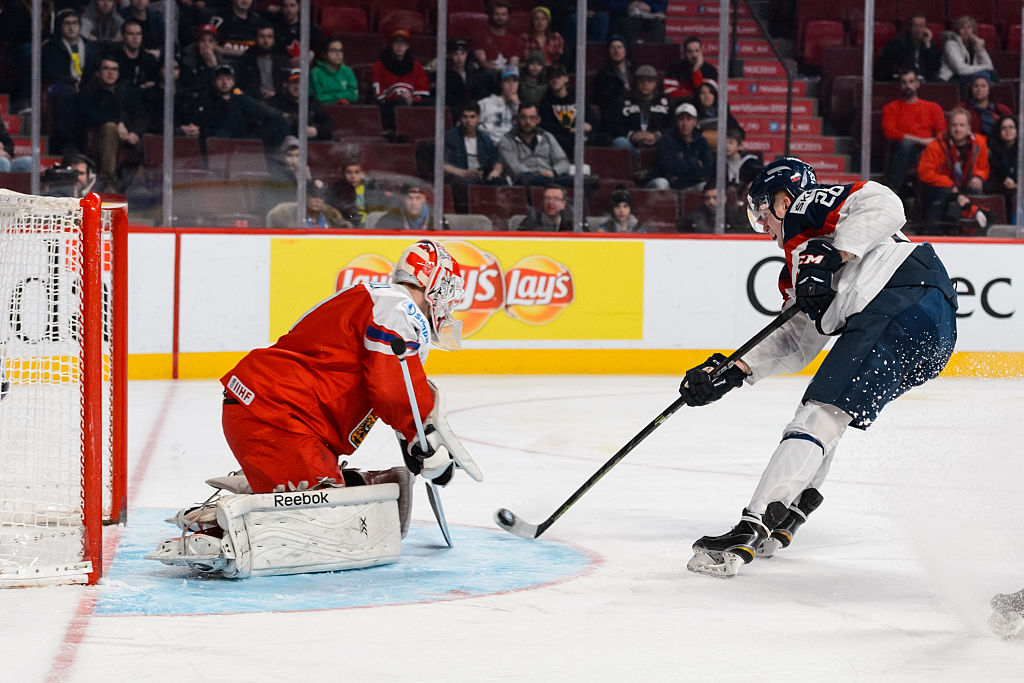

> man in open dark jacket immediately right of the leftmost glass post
[42,9,97,154]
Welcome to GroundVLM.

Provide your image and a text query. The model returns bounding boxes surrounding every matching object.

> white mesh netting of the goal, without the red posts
[0,190,111,586]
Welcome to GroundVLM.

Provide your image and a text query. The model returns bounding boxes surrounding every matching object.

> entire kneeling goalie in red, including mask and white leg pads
[146,240,483,579]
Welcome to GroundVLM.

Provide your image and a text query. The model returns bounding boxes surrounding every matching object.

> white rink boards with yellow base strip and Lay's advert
[121,228,1024,379]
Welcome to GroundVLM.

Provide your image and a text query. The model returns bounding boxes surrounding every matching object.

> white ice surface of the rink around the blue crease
[0,376,1024,683]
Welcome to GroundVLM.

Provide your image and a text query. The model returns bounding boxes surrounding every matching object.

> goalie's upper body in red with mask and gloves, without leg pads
[221,240,479,493]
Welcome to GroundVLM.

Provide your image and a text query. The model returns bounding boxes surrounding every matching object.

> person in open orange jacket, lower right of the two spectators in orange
[918,108,989,227]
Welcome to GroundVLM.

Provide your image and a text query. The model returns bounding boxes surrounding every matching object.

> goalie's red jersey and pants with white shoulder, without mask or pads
[220,284,434,492]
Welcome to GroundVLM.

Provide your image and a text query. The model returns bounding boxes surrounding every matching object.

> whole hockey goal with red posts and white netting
[0,190,127,588]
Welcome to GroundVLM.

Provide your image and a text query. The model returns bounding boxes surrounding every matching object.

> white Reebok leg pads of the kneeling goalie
[146,467,413,579]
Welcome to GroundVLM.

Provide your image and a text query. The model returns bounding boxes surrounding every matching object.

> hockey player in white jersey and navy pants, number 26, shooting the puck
[679,159,956,577]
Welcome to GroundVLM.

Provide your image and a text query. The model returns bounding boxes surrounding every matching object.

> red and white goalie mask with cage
[391,240,463,351]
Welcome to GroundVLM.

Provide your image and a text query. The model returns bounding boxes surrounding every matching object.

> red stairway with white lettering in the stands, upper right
[666,0,860,183]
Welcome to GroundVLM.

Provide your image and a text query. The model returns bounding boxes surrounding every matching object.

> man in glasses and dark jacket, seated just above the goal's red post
[78,56,148,193]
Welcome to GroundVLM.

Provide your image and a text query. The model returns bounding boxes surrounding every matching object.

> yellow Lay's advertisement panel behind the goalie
[269,238,644,341]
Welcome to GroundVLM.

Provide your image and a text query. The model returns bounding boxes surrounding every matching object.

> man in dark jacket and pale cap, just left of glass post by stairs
[647,102,713,189]
